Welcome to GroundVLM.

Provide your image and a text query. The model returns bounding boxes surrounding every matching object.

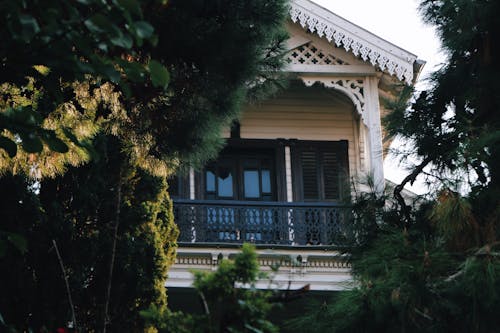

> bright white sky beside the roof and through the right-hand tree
[312,0,445,193]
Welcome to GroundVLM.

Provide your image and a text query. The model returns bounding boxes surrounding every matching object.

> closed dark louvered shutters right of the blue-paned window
[292,141,348,201]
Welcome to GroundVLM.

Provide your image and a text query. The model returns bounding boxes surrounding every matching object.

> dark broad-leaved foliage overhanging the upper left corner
[0,0,168,157]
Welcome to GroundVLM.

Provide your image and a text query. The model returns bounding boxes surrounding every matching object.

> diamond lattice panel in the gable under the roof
[287,43,349,65]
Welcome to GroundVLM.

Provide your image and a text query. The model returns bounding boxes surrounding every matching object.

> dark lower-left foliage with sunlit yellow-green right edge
[0,136,178,332]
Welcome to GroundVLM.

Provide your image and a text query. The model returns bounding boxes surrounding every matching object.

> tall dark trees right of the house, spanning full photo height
[292,0,500,332]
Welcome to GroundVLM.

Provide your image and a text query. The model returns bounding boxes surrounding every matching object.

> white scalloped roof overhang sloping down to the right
[290,0,423,84]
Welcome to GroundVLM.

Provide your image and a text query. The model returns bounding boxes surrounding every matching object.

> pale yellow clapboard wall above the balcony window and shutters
[226,82,364,175]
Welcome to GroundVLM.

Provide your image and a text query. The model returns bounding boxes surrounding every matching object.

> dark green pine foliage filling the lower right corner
[290,198,500,332]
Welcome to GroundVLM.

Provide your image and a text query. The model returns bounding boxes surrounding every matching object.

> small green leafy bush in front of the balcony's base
[142,244,278,333]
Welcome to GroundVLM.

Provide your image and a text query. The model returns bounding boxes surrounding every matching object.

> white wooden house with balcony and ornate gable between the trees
[166,0,423,291]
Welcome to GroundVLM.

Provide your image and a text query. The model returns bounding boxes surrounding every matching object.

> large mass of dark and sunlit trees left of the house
[0,0,286,331]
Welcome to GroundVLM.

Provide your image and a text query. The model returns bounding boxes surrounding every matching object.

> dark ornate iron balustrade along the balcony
[174,200,352,246]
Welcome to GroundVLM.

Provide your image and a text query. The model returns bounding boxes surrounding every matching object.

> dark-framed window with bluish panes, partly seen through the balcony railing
[199,140,284,242]
